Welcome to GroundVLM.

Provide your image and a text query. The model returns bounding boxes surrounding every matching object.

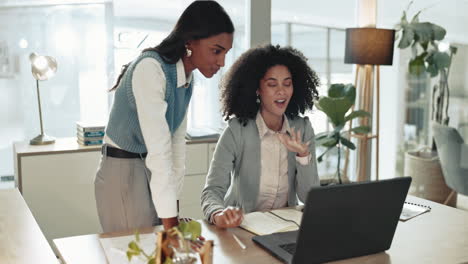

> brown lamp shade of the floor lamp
[345,28,395,65]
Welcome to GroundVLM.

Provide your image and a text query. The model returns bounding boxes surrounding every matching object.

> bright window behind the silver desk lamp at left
[0,3,113,176]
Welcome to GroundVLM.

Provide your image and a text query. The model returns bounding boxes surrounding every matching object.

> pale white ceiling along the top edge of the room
[113,0,468,43]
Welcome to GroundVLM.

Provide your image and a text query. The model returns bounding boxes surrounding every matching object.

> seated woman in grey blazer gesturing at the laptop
[201,45,319,227]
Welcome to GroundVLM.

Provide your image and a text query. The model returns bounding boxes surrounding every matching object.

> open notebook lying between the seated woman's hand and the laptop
[240,208,302,235]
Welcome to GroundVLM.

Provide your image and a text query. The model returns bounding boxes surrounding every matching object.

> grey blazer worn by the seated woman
[201,117,319,221]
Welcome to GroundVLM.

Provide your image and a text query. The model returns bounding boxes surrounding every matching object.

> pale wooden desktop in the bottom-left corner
[0,189,58,264]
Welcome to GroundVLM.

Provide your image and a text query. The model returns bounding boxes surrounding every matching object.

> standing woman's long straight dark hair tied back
[111,1,234,91]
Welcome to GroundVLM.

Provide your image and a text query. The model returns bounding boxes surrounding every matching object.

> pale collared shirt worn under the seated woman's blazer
[255,112,310,211]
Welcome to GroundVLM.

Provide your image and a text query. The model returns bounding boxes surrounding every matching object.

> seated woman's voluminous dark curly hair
[221,45,320,126]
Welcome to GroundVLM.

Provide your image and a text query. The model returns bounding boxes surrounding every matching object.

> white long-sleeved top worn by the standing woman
[104,58,192,218]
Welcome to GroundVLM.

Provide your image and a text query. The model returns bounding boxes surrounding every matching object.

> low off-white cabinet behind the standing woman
[14,138,215,242]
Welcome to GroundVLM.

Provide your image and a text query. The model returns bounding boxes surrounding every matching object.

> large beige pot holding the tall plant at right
[404,150,456,206]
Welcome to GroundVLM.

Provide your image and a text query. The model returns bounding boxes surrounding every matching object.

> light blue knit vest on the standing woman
[106,51,193,153]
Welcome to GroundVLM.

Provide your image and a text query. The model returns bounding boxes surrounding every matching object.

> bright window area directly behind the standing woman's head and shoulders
[114,4,245,134]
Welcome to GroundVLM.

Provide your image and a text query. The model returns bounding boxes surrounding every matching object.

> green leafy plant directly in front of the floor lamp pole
[315,83,371,184]
